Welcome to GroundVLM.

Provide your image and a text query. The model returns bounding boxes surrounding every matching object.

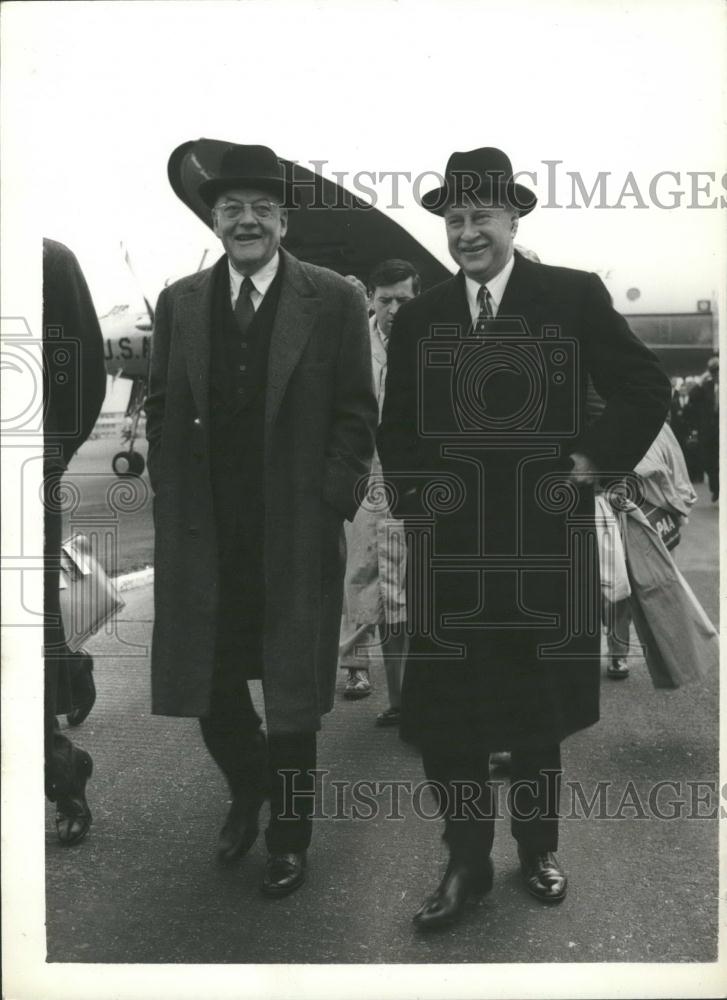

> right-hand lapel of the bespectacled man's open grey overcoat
[265,249,320,428]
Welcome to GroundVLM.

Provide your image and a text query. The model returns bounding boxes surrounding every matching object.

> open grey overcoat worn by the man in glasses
[146,250,378,733]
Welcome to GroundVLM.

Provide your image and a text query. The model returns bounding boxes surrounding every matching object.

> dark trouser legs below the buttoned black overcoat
[422,743,561,860]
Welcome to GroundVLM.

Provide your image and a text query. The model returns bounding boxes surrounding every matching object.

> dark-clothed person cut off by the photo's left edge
[43,239,106,847]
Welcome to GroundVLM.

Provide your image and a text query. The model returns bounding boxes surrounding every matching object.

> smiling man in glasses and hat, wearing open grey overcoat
[146,145,378,896]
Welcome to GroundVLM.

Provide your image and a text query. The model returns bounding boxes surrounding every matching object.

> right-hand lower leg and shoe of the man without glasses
[508,744,567,902]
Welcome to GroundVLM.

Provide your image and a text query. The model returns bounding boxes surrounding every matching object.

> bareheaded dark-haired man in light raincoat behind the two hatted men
[339,260,421,726]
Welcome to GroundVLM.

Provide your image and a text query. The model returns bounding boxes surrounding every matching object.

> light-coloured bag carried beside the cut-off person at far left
[59,534,124,653]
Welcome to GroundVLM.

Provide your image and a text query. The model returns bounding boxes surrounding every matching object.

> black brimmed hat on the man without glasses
[421,146,538,215]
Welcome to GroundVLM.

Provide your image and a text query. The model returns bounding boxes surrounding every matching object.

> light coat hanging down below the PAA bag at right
[619,507,719,688]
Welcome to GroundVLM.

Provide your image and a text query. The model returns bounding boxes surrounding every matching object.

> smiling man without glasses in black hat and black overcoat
[378,147,670,929]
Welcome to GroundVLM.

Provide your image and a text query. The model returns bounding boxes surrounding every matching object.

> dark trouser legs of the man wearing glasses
[199,656,316,854]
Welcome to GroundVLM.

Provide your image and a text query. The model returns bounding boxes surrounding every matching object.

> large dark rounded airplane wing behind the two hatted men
[168,139,450,288]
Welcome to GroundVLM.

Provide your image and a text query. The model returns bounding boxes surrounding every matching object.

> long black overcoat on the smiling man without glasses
[378,254,670,750]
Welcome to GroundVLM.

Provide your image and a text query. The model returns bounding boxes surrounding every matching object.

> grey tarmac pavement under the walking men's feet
[46,487,719,968]
